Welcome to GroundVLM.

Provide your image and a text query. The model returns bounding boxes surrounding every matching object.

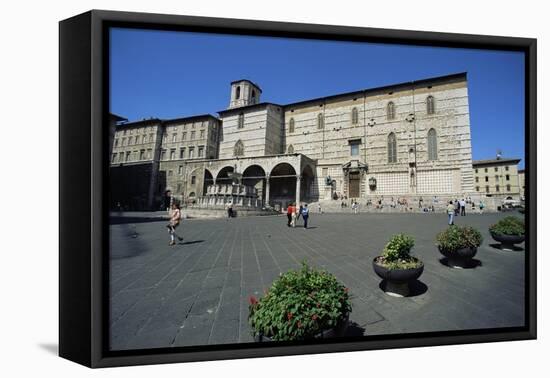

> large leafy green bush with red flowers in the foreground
[248,262,351,341]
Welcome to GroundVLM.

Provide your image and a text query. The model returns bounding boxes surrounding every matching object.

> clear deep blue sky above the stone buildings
[110,29,525,167]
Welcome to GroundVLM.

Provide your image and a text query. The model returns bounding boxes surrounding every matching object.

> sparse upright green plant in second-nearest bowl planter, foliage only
[377,234,422,270]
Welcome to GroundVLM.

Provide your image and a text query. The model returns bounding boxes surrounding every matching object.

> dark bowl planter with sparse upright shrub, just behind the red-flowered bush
[372,234,424,297]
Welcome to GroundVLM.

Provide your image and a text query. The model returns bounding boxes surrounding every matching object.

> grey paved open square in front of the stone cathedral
[110,213,527,350]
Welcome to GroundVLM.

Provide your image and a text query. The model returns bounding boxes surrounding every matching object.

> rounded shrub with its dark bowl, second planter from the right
[436,226,483,268]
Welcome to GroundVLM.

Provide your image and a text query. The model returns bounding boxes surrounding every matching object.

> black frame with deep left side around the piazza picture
[59,10,537,368]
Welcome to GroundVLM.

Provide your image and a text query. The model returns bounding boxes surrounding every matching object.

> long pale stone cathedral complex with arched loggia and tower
[111,73,481,209]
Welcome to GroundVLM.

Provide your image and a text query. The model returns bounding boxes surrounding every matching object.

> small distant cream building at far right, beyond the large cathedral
[473,157,522,200]
